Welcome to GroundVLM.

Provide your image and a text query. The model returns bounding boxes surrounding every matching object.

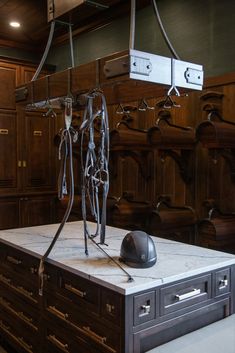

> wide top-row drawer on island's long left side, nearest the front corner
[59,271,100,313]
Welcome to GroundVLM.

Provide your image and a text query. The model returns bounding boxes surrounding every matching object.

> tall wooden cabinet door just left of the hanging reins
[22,111,56,191]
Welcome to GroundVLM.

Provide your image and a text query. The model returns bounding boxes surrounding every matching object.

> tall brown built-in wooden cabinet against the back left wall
[0,61,56,229]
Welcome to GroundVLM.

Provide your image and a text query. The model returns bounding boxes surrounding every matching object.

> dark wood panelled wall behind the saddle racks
[55,74,235,252]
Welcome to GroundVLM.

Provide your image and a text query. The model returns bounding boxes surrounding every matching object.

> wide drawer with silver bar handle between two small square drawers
[160,274,211,315]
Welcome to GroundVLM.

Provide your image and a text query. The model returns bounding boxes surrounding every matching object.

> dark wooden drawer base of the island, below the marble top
[0,236,232,353]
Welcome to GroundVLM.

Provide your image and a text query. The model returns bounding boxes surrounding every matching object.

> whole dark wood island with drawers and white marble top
[0,222,235,353]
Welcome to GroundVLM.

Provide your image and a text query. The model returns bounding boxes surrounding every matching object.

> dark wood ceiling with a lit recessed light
[0,0,150,52]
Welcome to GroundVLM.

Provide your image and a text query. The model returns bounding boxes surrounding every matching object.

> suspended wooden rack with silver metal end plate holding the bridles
[16,0,203,104]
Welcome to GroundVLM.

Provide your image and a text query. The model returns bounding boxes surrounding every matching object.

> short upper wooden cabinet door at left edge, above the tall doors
[0,62,19,109]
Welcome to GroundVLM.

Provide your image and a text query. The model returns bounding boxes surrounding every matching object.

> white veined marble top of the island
[0,221,235,295]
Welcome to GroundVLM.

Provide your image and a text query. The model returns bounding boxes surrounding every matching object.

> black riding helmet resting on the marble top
[120,230,157,268]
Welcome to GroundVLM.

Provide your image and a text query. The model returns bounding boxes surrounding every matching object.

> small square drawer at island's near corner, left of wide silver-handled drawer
[134,291,156,326]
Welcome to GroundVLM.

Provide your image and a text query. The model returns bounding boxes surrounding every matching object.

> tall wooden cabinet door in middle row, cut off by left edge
[0,110,18,192]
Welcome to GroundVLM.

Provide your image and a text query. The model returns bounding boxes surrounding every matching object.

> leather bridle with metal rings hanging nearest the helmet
[80,90,109,254]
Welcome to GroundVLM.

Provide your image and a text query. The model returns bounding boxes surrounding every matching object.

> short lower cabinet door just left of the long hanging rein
[20,195,55,227]
